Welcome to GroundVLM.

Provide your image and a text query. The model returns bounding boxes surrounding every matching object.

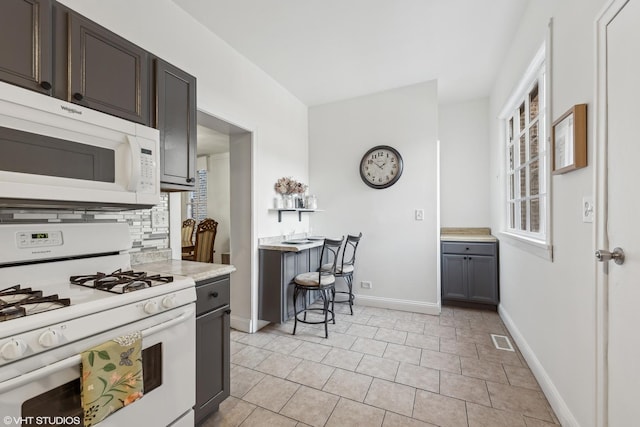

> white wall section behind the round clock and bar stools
[309,81,439,313]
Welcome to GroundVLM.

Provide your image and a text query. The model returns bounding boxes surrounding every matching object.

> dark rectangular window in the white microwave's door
[0,127,115,182]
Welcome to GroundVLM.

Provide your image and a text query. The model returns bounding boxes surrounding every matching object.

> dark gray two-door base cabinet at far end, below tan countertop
[441,242,500,309]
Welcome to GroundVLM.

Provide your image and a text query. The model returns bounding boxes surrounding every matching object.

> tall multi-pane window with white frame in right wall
[504,59,549,243]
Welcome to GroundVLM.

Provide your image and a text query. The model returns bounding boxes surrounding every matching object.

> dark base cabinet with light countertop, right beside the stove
[136,260,236,425]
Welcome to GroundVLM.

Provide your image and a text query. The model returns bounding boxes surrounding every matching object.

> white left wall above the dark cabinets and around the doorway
[61,0,308,334]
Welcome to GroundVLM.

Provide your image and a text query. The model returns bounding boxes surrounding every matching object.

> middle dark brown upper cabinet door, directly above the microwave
[65,11,150,125]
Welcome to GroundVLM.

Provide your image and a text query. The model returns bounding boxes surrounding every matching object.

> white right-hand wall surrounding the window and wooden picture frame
[490,0,604,427]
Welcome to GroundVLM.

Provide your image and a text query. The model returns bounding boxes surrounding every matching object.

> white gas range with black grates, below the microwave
[0,223,196,427]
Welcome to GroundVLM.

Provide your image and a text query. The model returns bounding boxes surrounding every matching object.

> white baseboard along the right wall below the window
[498,304,580,427]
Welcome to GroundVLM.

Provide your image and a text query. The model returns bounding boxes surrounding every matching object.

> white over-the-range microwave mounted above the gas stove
[0,82,160,210]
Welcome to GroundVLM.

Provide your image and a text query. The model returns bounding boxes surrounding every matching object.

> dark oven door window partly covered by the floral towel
[22,343,162,427]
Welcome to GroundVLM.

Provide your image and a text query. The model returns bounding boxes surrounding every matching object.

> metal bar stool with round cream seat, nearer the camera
[292,236,344,338]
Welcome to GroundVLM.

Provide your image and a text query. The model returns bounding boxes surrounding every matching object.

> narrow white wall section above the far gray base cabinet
[438,98,490,227]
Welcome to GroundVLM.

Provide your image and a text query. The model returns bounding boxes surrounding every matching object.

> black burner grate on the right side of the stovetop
[69,269,173,294]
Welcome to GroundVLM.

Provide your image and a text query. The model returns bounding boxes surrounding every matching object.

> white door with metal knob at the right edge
[598,0,640,427]
